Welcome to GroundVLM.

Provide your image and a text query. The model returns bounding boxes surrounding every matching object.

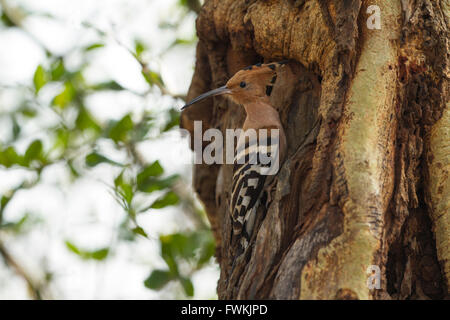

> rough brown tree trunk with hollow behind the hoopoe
[181,0,450,299]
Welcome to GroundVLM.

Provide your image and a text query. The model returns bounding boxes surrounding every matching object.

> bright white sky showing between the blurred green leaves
[0,0,218,299]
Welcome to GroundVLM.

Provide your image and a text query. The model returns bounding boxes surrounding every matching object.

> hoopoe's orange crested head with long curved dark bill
[182,61,287,109]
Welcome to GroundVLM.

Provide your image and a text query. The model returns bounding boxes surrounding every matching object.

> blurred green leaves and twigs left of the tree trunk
[0,0,215,297]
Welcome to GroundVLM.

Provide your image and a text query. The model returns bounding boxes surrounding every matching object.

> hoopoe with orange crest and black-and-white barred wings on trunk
[182,61,287,255]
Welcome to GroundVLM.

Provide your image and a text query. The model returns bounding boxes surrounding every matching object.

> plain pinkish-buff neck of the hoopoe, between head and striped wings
[243,101,281,130]
